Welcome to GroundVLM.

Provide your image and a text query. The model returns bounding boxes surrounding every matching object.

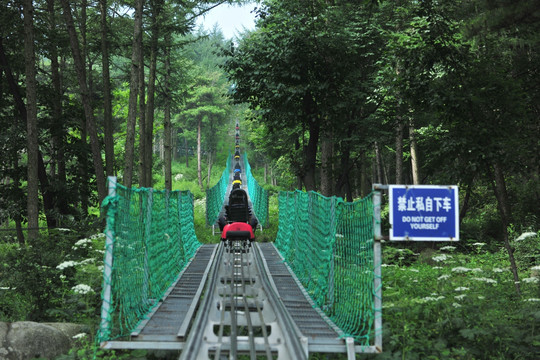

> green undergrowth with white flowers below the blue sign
[360,242,540,360]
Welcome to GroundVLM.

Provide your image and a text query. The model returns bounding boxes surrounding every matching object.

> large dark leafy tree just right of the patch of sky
[225,1,379,194]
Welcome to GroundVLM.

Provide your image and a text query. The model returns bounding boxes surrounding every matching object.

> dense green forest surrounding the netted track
[0,0,540,359]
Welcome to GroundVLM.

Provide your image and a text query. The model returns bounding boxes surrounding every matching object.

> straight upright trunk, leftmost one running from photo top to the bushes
[23,0,39,239]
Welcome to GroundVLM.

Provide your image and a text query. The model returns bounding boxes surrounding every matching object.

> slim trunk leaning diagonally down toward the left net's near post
[61,0,107,202]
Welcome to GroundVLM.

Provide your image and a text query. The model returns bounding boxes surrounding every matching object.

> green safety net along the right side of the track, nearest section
[275,190,381,346]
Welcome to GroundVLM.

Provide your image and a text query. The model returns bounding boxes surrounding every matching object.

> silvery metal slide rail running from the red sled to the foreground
[180,241,307,360]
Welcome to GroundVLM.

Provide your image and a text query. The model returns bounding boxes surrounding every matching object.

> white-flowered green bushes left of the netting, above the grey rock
[0,229,103,323]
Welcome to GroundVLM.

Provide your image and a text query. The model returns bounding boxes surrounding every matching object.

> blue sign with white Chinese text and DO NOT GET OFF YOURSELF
[388,185,459,241]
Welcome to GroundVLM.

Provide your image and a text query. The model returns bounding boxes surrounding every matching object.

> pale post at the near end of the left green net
[100,176,117,342]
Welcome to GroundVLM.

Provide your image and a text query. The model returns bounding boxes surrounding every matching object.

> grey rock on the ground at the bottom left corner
[0,321,85,360]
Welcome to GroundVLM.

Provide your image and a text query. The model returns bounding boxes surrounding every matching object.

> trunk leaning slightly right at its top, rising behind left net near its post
[124,0,144,188]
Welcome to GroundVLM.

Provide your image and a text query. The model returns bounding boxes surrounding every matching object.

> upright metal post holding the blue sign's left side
[372,184,387,352]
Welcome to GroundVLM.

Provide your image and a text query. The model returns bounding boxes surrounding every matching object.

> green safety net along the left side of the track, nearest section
[97,183,201,342]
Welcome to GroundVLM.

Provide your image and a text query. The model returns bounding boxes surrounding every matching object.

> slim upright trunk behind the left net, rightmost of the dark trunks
[163,32,172,190]
